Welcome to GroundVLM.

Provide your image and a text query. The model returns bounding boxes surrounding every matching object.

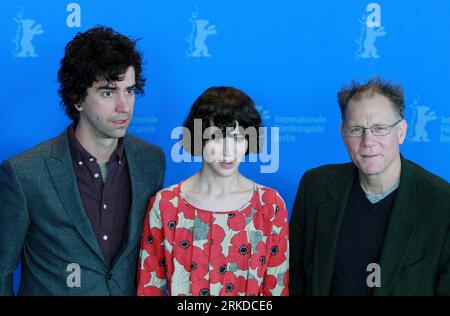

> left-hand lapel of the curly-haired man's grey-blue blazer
[46,129,106,264]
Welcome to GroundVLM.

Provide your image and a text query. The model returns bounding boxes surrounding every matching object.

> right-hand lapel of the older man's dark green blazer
[373,157,416,295]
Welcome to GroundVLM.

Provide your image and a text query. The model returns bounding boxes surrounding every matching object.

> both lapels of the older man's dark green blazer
[312,156,417,295]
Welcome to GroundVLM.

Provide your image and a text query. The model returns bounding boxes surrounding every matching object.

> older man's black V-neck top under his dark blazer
[331,176,398,296]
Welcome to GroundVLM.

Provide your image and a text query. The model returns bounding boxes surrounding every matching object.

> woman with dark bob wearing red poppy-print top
[138,87,289,296]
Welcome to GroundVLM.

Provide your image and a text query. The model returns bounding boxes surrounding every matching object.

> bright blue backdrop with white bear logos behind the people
[0,0,450,294]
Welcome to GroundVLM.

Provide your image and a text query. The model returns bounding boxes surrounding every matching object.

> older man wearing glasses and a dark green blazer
[290,78,450,296]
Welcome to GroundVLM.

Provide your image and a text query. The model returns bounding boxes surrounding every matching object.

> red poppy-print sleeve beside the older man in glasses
[262,193,289,296]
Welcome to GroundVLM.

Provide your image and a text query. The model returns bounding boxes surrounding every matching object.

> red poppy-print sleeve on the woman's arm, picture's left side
[137,193,167,296]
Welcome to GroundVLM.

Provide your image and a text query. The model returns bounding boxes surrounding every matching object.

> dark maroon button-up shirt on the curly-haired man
[68,126,131,265]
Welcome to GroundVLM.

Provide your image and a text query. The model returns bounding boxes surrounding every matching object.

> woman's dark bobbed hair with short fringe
[183,87,261,156]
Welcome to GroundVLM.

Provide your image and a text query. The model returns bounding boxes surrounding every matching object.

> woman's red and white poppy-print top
[138,183,289,296]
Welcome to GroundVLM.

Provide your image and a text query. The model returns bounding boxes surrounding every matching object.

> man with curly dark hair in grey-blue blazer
[0,26,165,295]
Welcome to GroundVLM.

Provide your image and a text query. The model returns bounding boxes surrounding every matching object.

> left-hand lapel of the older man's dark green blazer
[312,164,356,296]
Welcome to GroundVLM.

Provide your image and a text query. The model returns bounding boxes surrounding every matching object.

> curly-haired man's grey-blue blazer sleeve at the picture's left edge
[0,161,30,296]
